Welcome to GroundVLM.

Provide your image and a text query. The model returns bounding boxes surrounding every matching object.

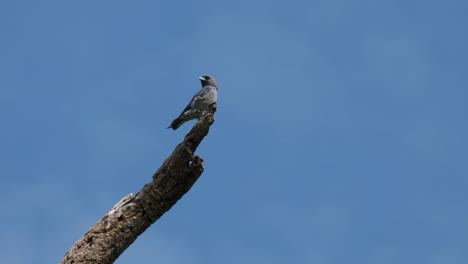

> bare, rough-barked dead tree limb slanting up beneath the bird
[61,103,216,264]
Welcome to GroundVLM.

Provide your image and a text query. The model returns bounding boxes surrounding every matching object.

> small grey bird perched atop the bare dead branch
[167,75,218,130]
